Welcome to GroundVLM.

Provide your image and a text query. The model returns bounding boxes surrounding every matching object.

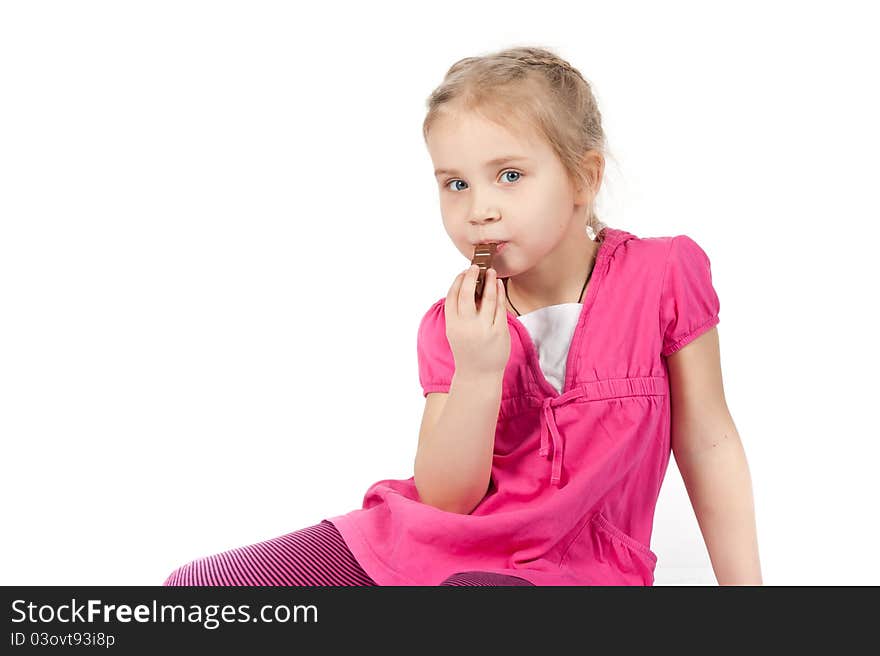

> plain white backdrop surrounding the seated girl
[0,0,880,585]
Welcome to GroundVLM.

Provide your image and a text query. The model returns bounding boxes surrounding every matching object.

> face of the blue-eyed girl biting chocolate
[426,112,588,278]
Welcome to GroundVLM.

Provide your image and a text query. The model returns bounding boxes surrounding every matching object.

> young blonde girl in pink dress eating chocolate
[165,47,761,585]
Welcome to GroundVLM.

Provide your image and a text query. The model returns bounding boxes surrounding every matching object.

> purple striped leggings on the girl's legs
[163,519,534,586]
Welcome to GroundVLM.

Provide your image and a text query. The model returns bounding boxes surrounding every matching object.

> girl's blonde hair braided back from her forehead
[422,46,608,234]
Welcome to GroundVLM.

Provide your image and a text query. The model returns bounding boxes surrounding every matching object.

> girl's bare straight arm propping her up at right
[667,327,762,585]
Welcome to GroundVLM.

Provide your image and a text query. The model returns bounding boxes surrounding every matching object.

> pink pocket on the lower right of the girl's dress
[560,511,657,585]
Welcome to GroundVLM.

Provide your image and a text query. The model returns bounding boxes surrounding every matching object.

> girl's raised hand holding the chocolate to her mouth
[445,264,510,376]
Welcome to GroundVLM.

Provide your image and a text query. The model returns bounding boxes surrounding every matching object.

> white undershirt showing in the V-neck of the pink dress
[517,303,583,394]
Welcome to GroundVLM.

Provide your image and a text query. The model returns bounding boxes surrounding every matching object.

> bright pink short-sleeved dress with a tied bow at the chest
[329,227,719,586]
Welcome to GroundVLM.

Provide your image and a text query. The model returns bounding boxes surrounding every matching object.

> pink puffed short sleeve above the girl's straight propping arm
[660,235,720,357]
